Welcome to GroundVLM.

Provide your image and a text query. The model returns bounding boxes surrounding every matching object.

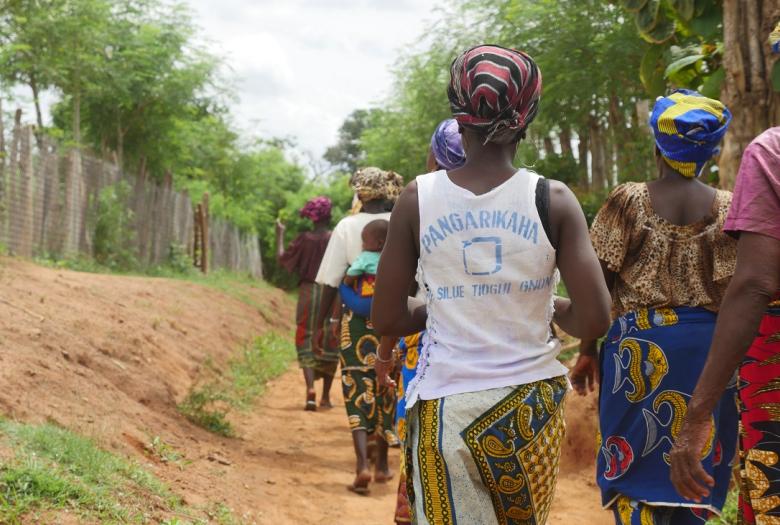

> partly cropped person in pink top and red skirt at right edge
[671,127,780,525]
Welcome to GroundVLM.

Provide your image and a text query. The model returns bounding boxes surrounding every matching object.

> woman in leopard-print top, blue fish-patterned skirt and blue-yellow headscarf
[571,90,737,525]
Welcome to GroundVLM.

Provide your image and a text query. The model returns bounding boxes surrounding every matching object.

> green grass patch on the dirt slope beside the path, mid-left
[179,332,295,437]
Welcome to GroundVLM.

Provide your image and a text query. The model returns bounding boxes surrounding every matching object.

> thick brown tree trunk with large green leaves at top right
[622,0,780,188]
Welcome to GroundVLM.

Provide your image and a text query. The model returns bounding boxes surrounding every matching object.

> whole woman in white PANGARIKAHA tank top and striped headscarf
[372,46,610,524]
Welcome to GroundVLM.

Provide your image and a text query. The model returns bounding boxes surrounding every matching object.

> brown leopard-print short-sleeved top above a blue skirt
[590,182,737,317]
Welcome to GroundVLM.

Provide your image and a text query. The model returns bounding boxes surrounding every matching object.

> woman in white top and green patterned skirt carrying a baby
[316,168,403,494]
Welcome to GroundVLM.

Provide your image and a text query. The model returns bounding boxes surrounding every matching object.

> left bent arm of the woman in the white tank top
[371,181,427,337]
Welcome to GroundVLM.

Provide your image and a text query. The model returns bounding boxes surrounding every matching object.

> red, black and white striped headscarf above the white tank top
[447,45,542,144]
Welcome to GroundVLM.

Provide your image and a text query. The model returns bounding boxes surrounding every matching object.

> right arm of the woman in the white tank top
[550,181,611,339]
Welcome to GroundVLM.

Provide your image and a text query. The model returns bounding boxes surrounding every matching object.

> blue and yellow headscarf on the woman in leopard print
[650,89,731,178]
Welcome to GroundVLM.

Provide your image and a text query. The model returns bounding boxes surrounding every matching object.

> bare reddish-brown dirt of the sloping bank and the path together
[0,258,609,525]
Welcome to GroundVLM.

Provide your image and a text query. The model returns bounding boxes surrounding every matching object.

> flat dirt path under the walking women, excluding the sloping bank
[216,370,609,525]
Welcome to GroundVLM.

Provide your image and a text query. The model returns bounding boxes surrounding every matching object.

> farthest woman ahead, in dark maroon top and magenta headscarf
[276,197,338,411]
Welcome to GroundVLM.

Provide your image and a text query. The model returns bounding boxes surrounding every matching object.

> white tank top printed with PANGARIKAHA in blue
[407,169,567,406]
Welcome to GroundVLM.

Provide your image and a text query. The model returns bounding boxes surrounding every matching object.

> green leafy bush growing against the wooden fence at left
[93,181,138,270]
